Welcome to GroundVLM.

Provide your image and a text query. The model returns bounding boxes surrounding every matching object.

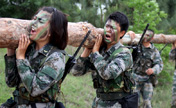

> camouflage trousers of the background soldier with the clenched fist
[135,82,153,108]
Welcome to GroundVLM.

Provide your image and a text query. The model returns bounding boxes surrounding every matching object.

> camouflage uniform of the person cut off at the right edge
[169,49,176,108]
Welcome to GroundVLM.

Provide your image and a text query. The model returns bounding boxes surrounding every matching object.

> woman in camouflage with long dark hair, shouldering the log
[1,7,68,108]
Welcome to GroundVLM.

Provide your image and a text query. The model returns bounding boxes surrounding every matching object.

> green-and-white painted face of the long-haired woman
[29,11,51,40]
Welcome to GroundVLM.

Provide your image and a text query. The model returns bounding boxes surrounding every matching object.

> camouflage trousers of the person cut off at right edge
[171,70,176,108]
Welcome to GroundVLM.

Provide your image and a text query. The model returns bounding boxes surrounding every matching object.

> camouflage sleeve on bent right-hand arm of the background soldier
[152,50,163,75]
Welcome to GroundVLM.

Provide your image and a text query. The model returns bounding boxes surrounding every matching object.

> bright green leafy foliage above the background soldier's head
[126,0,166,33]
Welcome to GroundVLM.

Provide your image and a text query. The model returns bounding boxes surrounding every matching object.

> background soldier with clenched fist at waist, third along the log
[132,30,163,108]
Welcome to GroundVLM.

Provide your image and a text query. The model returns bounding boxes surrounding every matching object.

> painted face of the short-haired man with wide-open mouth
[104,20,118,43]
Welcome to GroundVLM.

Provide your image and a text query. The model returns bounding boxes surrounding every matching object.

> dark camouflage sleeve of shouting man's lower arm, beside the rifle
[71,57,94,76]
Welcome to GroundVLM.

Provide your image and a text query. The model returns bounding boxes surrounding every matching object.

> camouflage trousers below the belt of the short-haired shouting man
[92,97,122,108]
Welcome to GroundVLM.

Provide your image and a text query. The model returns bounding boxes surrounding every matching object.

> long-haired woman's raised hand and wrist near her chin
[16,34,30,59]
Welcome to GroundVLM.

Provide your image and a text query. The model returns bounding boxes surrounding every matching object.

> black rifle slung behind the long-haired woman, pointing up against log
[61,30,91,82]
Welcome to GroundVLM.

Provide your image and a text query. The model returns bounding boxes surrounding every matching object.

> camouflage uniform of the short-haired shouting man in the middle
[71,42,133,108]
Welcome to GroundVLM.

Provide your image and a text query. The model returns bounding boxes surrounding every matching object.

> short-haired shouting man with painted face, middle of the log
[71,12,138,108]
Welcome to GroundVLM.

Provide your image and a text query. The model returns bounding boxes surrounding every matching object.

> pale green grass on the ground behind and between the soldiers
[0,47,174,108]
